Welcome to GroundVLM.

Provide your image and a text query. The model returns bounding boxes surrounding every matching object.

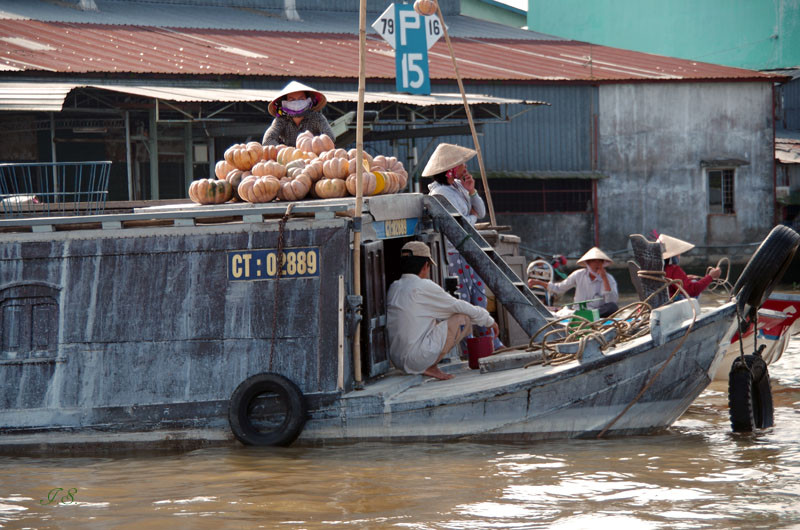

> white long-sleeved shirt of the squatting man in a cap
[386,274,494,374]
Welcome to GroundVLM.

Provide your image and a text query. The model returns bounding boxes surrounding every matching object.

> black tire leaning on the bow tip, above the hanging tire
[731,225,800,316]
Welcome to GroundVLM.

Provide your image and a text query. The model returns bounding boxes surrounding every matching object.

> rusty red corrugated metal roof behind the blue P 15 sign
[0,19,778,82]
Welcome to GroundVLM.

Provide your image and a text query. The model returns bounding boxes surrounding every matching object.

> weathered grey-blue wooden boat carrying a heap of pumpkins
[0,194,800,452]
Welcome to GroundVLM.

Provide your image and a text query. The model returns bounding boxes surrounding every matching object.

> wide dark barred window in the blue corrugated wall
[489,178,592,213]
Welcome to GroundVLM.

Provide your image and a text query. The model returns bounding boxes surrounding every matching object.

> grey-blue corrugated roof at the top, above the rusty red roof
[0,0,552,40]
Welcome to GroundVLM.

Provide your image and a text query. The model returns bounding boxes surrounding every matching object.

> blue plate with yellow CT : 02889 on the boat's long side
[228,247,319,281]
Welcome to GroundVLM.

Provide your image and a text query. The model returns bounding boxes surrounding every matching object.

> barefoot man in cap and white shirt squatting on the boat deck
[386,241,500,380]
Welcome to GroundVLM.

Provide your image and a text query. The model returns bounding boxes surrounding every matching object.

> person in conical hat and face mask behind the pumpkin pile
[261,81,336,146]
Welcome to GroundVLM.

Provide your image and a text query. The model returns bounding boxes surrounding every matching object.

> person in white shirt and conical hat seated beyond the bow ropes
[528,247,619,317]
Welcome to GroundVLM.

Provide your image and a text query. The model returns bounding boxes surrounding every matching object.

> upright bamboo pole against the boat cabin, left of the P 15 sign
[353,0,367,387]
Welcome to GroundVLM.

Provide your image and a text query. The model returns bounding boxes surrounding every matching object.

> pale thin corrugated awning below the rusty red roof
[0,81,545,112]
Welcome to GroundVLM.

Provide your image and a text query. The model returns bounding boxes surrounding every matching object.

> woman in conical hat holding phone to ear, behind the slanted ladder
[422,143,503,355]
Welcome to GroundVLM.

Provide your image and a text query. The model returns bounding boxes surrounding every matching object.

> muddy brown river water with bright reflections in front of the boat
[0,336,800,530]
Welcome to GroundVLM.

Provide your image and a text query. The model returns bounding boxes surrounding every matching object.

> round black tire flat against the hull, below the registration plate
[228,373,308,446]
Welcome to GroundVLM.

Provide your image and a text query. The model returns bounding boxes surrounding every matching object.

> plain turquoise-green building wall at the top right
[528,0,800,70]
